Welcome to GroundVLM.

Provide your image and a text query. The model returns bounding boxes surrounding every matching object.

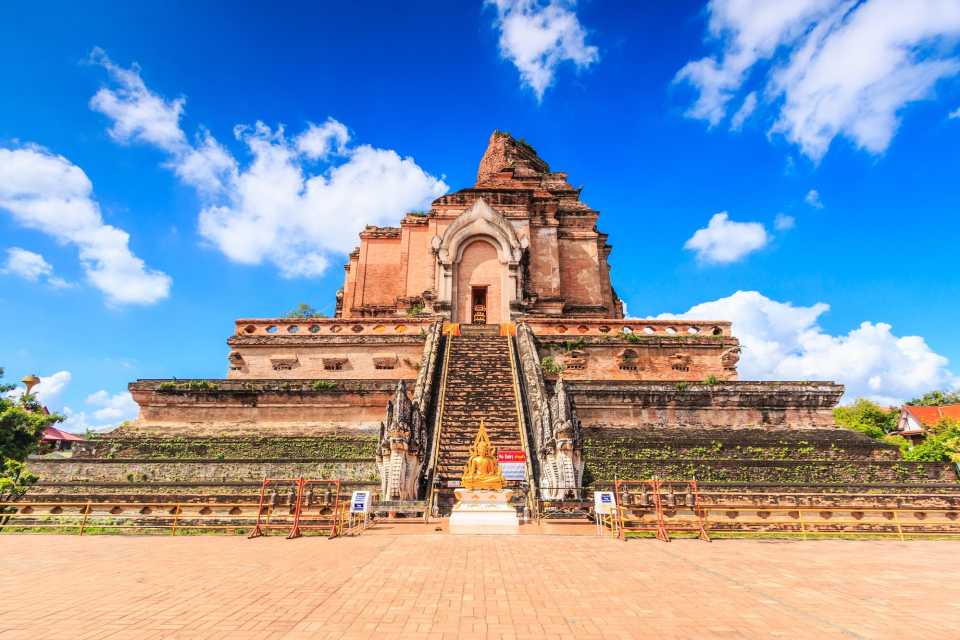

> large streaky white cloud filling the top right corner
[676,0,960,162]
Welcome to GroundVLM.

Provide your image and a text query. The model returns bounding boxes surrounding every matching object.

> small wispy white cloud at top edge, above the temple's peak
[486,0,600,100]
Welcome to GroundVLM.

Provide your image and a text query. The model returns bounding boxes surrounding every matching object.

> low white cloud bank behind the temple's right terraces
[660,291,960,404]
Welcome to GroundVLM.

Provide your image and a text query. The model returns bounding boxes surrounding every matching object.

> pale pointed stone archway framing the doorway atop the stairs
[432,199,525,324]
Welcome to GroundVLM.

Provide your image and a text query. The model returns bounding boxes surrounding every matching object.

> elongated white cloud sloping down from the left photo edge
[0,146,171,305]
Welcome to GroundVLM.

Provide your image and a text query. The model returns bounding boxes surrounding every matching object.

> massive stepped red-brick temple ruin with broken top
[24,132,957,526]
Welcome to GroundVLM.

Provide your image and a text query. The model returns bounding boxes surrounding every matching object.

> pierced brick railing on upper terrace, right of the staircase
[525,318,733,337]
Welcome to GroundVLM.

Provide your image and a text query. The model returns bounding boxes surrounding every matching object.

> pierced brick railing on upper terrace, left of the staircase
[235,317,435,336]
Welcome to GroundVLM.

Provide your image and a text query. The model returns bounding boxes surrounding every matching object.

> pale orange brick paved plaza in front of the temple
[0,534,960,640]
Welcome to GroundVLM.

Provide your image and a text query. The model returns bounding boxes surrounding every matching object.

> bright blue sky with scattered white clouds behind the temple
[0,0,960,428]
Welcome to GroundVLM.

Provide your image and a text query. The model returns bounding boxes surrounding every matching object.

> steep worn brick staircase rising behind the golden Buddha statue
[434,325,524,513]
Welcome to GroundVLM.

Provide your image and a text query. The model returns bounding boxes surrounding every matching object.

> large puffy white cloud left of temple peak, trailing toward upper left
[91,48,448,277]
